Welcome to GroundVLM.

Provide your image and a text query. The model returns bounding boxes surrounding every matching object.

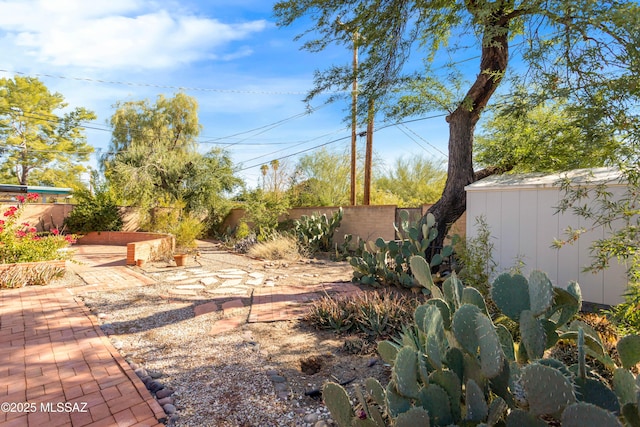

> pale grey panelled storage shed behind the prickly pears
[465,168,628,305]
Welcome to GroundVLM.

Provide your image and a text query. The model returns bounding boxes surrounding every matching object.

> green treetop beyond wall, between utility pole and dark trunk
[374,156,447,207]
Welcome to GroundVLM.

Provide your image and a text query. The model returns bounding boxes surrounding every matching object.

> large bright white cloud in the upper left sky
[0,0,268,70]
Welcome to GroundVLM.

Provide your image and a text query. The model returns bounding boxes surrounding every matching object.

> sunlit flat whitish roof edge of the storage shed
[464,168,624,191]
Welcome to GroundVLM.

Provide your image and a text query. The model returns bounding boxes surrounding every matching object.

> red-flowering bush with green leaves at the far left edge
[0,193,75,264]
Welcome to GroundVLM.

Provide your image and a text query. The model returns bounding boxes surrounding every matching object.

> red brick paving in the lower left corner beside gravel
[0,287,165,427]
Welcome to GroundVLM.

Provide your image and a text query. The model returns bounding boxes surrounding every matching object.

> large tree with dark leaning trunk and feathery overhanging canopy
[274,0,640,247]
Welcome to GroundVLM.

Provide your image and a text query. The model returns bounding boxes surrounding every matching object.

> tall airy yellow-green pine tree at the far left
[0,76,96,187]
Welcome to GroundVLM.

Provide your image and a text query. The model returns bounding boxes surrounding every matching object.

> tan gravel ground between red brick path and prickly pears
[58,246,350,427]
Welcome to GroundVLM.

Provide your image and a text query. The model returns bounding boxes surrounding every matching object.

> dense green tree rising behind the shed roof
[475,96,621,173]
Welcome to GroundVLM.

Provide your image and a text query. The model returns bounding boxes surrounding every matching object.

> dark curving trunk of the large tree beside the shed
[423,15,509,252]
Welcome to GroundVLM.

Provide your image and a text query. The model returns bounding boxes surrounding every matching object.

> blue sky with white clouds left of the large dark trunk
[0,0,448,187]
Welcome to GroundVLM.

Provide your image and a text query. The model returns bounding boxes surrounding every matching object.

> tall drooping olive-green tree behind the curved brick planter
[102,93,201,207]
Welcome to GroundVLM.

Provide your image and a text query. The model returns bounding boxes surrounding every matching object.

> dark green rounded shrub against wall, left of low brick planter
[64,187,122,233]
